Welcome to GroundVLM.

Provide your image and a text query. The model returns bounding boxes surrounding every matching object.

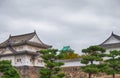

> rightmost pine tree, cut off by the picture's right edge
[105,50,120,78]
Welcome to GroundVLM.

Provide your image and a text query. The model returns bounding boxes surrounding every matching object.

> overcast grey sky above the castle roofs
[0,0,120,53]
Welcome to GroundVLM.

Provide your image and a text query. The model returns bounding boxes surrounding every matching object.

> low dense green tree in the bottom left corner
[0,60,20,78]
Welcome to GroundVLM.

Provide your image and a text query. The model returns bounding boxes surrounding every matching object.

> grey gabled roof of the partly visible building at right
[100,32,120,48]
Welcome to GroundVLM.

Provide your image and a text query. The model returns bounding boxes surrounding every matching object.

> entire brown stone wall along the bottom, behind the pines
[13,66,120,78]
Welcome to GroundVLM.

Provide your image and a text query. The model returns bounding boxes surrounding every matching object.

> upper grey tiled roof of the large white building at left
[0,31,52,48]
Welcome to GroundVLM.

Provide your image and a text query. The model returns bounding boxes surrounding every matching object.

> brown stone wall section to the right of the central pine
[62,66,120,78]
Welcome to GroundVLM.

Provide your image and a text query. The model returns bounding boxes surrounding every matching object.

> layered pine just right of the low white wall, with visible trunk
[80,46,105,78]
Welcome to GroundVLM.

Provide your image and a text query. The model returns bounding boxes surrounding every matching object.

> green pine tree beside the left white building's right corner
[39,49,65,78]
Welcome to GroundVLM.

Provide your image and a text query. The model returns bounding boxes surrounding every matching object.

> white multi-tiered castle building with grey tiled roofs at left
[0,32,52,66]
